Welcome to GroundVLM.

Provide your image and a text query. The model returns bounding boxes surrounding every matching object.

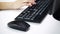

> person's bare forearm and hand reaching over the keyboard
[0,0,36,9]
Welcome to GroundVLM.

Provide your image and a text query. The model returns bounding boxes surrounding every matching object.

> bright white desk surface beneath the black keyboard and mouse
[0,6,60,34]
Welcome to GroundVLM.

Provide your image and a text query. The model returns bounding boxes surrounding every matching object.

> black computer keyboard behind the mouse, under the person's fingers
[15,0,53,23]
